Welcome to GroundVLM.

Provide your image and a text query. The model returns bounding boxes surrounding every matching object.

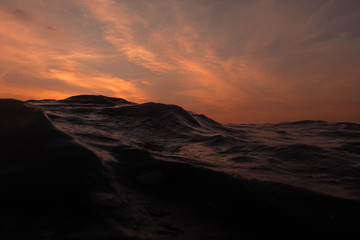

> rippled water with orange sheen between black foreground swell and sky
[33,103,360,199]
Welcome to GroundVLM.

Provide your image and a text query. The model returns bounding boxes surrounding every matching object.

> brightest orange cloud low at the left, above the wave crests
[0,0,144,100]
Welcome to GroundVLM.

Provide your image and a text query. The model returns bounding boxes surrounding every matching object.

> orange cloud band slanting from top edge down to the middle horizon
[82,1,249,110]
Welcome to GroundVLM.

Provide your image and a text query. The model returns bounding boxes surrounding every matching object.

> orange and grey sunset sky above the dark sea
[0,0,360,123]
